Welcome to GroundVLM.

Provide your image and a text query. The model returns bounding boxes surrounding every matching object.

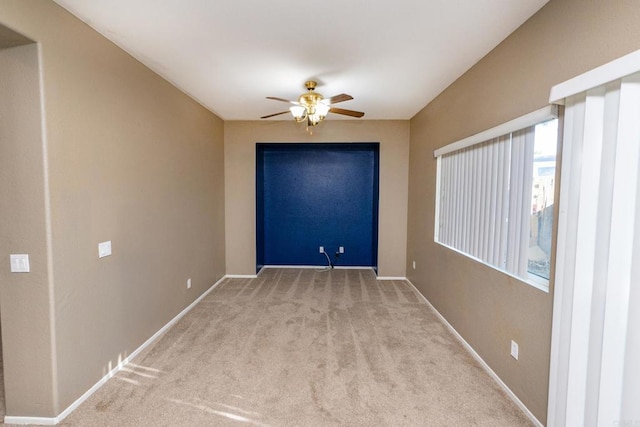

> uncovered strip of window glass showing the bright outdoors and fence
[527,119,558,280]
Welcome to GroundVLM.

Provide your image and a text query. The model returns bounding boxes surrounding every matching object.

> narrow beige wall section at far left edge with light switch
[0,44,54,415]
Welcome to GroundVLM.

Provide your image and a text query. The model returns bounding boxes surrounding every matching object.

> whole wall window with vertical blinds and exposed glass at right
[435,107,558,290]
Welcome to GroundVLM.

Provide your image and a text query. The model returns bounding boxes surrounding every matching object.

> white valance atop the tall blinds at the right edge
[549,50,640,104]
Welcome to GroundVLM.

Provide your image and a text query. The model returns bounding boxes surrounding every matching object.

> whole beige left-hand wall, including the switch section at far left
[0,0,225,417]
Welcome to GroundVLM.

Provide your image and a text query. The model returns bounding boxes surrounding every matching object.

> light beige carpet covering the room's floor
[26,269,531,427]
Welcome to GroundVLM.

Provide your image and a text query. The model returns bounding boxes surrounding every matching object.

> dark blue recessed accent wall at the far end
[256,143,379,270]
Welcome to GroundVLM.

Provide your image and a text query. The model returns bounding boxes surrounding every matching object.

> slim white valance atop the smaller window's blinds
[433,105,558,157]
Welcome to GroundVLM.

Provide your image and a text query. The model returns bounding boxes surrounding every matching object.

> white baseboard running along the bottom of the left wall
[4,276,228,426]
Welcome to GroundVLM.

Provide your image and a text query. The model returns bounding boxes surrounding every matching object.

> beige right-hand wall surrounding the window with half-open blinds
[407,0,640,422]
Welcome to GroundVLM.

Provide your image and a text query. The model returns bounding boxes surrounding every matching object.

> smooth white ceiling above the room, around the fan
[55,0,548,120]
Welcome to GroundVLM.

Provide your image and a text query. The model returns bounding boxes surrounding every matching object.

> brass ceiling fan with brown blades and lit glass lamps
[260,80,364,129]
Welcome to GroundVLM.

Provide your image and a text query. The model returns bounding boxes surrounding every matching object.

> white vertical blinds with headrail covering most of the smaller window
[434,108,557,288]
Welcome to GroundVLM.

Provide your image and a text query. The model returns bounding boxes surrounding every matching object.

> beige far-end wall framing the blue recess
[224,119,409,277]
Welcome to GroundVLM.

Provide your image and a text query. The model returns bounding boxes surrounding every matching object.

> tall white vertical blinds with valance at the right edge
[547,55,640,427]
